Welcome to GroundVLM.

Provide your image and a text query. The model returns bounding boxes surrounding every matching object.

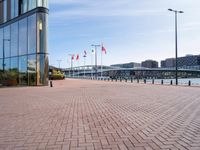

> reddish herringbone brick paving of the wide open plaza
[0,80,200,150]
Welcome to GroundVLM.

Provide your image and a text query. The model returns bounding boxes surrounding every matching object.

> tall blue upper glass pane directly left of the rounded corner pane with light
[28,15,36,54]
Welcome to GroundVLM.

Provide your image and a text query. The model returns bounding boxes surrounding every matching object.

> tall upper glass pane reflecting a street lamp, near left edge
[3,26,10,57]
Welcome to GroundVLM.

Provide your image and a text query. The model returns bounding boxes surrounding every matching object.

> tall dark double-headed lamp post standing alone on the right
[168,8,184,85]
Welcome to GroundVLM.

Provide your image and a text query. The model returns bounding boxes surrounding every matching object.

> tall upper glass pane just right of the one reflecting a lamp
[11,22,18,56]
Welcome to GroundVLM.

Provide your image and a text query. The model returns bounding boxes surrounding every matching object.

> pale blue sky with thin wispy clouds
[49,0,200,67]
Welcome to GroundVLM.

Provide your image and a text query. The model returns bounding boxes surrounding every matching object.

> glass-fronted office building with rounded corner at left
[0,0,48,86]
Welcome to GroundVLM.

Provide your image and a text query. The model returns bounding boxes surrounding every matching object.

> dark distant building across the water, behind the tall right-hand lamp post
[161,55,200,69]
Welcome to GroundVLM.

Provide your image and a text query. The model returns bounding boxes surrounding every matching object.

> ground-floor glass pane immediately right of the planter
[19,56,28,85]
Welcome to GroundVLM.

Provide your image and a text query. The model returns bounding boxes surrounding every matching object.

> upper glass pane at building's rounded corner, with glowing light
[37,13,48,53]
